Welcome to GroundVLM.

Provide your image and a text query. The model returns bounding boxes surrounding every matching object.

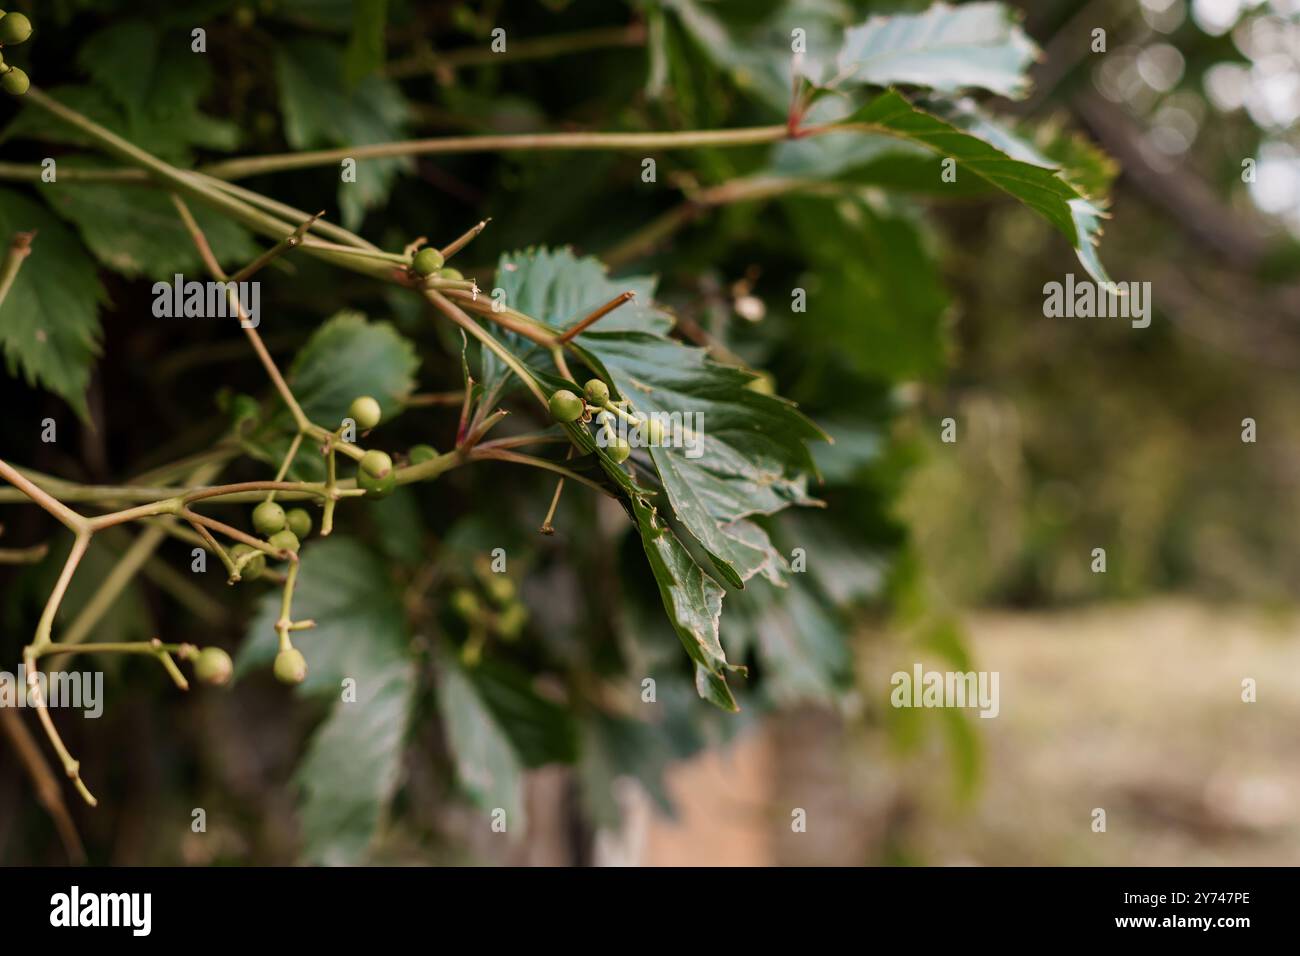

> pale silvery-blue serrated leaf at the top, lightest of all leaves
[837,3,1039,99]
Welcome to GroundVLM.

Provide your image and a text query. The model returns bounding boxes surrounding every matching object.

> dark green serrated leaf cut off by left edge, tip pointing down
[0,190,105,419]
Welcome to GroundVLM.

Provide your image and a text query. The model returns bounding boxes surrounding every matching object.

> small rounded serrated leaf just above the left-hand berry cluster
[289,312,420,427]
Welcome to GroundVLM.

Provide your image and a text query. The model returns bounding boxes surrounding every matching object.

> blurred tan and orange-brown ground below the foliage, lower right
[629,598,1300,866]
